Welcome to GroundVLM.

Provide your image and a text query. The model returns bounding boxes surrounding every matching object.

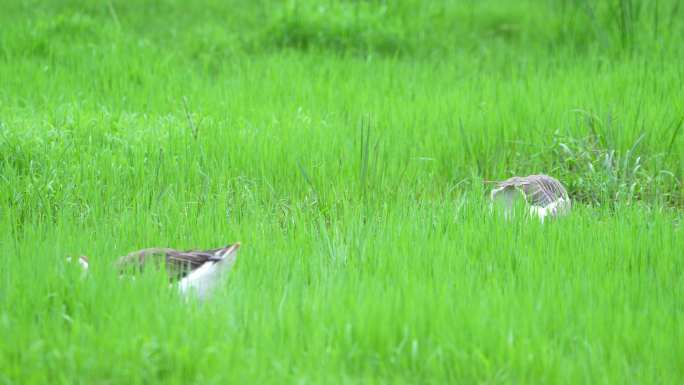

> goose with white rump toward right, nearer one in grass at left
[67,243,240,300]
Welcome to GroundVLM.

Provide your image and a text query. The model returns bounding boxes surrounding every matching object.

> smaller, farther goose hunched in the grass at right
[485,174,571,223]
